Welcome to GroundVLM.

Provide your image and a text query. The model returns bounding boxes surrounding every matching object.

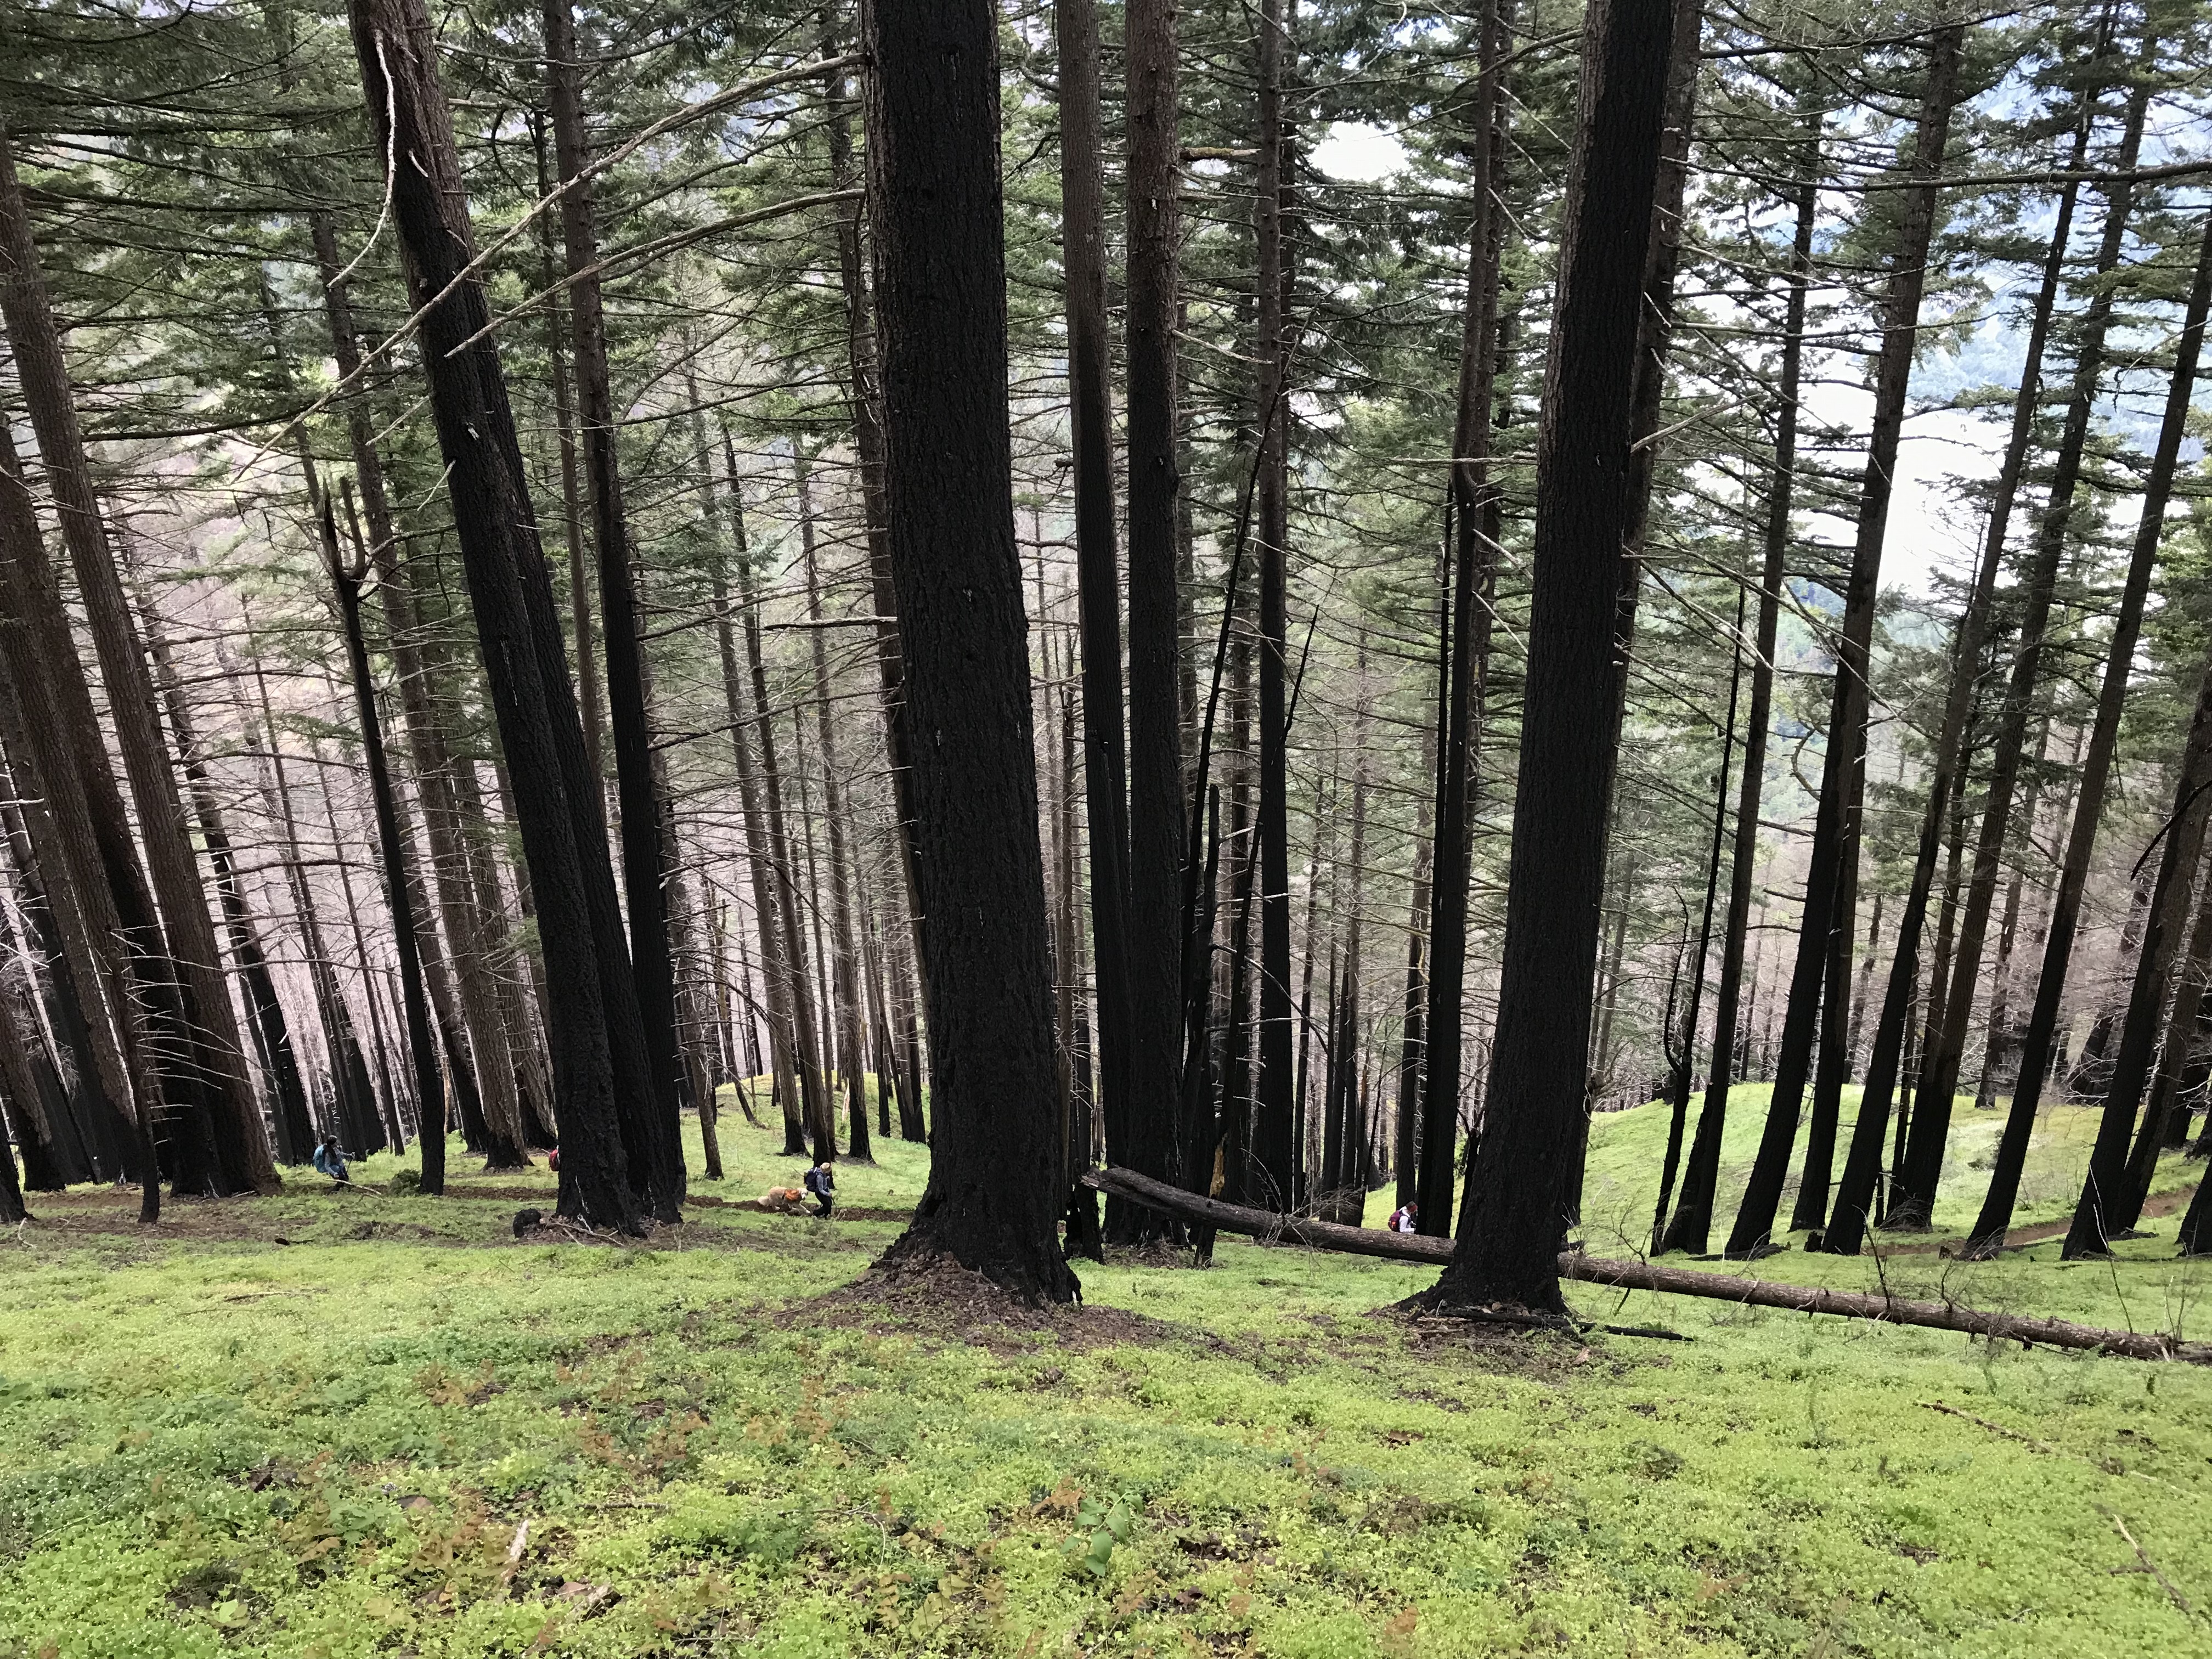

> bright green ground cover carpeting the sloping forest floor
[0,1095,2212,1659]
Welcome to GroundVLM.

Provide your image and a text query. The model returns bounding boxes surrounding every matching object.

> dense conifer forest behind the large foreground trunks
[0,0,2212,1254]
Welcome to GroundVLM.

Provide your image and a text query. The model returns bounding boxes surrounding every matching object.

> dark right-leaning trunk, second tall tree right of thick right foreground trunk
[1728,24,1964,1256]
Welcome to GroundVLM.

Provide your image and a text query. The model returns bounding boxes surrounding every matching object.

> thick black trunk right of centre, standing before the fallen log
[1425,0,1677,1321]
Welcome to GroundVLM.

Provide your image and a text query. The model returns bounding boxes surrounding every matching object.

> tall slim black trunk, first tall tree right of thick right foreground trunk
[1657,109,1822,1254]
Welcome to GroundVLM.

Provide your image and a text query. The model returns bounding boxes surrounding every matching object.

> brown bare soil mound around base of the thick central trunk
[800,1259,1197,1354]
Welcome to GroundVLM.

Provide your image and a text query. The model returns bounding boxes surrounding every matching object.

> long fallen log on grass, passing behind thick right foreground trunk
[1084,1170,2212,1365]
